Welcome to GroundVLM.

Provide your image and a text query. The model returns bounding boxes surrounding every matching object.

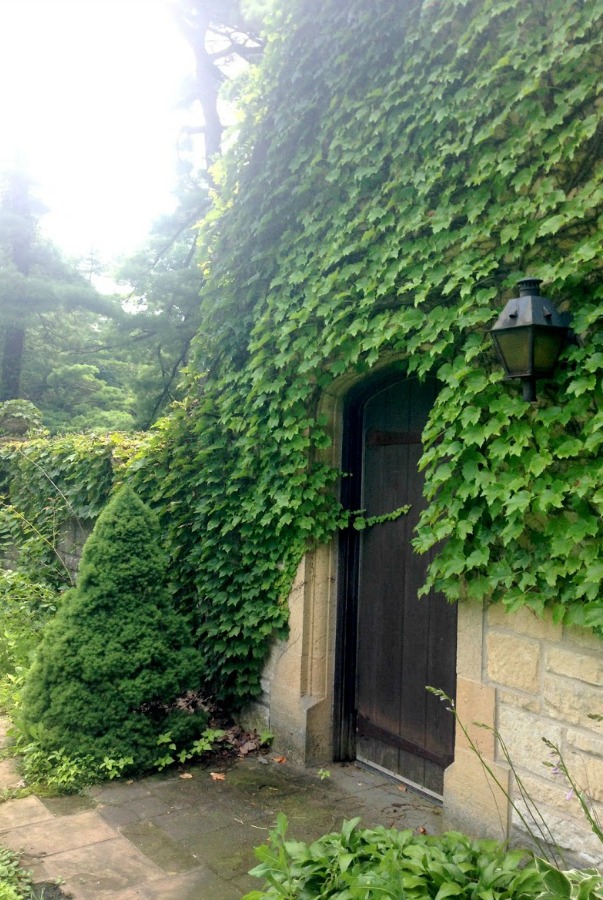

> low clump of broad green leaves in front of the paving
[245,814,544,900]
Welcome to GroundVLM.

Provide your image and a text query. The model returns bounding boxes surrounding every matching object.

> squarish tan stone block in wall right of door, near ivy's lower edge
[486,631,541,694]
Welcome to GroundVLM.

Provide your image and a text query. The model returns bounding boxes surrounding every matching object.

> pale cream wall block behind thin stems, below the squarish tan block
[498,704,563,775]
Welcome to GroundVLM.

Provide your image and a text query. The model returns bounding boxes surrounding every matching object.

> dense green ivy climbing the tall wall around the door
[5,0,603,704]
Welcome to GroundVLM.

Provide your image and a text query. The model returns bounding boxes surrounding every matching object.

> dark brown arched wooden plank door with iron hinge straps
[340,376,456,795]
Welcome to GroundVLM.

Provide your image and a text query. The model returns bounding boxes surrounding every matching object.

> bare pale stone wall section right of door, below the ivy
[444,606,603,865]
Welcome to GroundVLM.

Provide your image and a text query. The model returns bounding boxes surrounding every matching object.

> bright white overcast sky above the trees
[0,0,193,259]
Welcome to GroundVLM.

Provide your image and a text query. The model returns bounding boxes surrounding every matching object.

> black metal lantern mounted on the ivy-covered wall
[490,278,571,402]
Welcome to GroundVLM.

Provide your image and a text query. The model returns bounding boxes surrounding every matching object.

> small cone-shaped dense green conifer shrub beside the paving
[22,487,206,771]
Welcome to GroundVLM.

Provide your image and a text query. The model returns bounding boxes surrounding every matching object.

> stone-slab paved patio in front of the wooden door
[0,740,442,900]
